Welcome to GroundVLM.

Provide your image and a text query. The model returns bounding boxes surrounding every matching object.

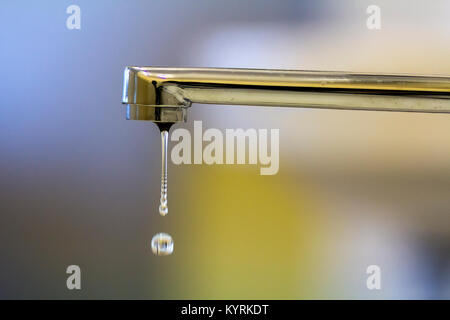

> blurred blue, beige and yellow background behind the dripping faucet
[0,0,450,299]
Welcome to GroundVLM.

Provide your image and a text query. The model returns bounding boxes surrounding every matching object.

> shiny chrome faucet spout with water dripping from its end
[122,67,450,125]
